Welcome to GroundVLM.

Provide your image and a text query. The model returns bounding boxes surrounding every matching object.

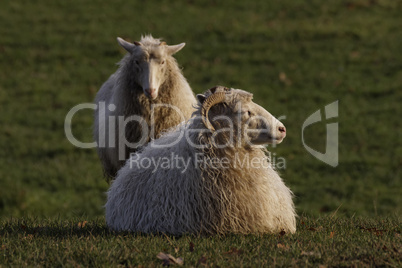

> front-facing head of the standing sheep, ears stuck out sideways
[117,36,185,99]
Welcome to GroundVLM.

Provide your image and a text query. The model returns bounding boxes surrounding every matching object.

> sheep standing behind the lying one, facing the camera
[93,35,196,178]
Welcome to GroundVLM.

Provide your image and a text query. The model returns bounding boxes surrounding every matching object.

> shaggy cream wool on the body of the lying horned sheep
[105,87,296,235]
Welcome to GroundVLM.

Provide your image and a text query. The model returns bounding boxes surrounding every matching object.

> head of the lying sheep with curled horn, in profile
[197,86,286,145]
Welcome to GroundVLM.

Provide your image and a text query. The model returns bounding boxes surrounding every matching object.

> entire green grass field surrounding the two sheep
[0,0,402,266]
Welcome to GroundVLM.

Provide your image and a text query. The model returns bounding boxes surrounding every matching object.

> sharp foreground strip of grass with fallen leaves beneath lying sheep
[0,216,402,267]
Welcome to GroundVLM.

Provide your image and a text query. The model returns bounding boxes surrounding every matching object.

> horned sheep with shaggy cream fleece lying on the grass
[105,86,296,235]
